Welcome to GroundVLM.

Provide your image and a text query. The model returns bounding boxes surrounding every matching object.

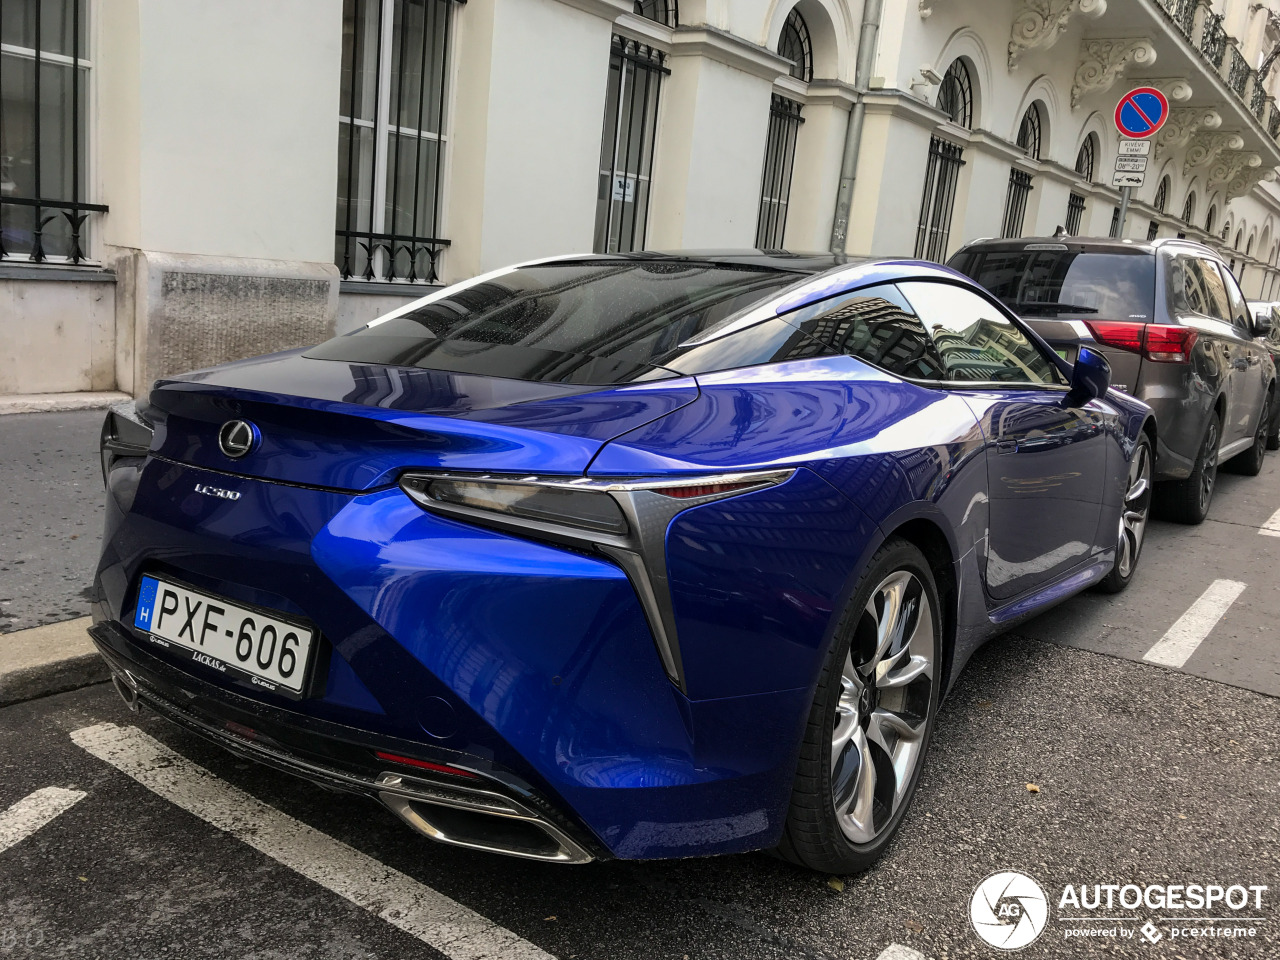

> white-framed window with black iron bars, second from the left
[334,0,454,283]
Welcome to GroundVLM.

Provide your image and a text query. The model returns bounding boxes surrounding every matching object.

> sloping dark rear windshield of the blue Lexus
[307,260,805,384]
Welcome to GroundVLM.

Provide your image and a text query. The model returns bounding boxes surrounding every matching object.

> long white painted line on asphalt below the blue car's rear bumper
[72,723,554,960]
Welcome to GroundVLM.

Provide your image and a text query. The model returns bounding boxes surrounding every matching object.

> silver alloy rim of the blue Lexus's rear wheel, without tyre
[831,570,936,844]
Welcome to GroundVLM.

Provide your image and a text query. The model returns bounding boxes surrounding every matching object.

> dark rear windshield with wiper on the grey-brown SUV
[952,247,1156,321]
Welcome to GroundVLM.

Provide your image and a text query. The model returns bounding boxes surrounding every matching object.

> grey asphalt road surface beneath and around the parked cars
[0,409,1280,960]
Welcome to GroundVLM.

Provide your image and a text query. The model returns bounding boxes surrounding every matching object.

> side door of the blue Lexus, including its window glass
[899,280,1119,602]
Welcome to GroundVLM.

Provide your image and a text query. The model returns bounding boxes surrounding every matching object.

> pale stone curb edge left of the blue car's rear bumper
[0,617,110,707]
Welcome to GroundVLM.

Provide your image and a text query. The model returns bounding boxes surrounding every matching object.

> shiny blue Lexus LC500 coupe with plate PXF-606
[92,252,1155,872]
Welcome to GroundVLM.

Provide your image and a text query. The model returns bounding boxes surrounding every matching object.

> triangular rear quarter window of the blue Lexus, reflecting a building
[787,284,947,380]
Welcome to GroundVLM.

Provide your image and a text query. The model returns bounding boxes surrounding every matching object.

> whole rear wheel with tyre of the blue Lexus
[777,539,942,873]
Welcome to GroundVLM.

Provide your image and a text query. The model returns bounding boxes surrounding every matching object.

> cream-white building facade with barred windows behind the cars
[0,0,1280,394]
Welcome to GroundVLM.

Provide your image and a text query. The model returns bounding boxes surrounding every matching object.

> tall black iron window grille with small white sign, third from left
[595,35,671,253]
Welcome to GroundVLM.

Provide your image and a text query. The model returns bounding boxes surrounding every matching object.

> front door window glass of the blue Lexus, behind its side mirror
[899,280,1062,384]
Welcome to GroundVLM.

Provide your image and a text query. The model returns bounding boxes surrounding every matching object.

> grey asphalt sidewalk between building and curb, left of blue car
[0,410,104,634]
